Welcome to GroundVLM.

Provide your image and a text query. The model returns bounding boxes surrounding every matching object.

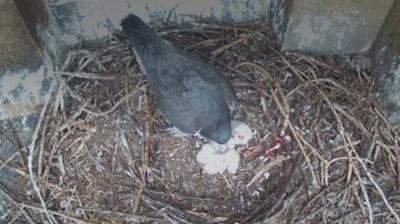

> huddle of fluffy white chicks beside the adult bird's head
[196,121,253,174]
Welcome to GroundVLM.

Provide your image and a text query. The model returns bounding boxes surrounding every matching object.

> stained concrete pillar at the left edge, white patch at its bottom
[0,0,46,120]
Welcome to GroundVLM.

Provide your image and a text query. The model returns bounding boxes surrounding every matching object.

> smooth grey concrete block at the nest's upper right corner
[282,0,393,54]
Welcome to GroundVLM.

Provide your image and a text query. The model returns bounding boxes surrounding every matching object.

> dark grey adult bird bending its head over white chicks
[121,14,234,144]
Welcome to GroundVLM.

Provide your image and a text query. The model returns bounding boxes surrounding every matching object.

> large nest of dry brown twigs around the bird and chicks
[1,20,400,223]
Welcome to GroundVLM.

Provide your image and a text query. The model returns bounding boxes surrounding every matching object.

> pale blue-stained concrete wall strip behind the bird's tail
[50,0,271,44]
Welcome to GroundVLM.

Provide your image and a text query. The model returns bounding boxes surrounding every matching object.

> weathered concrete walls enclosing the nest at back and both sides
[0,0,400,124]
